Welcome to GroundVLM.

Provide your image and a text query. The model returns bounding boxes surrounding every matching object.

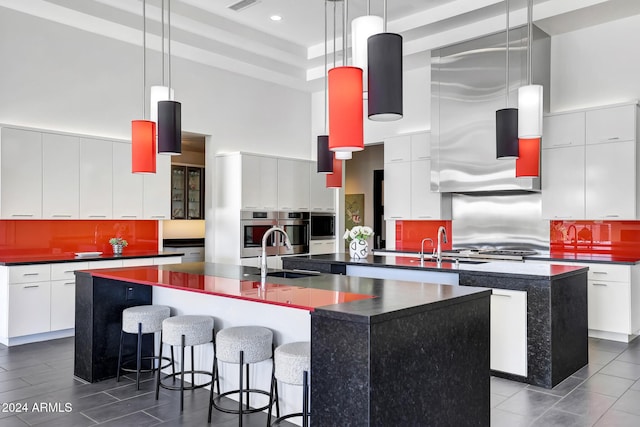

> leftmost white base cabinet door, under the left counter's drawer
[8,282,51,338]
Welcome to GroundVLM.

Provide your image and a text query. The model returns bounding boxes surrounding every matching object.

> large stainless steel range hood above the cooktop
[431,27,551,192]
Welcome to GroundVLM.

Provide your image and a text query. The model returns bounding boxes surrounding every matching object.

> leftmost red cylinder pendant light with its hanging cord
[131,0,156,173]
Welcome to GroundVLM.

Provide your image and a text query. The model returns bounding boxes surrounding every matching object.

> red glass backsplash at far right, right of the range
[549,221,640,258]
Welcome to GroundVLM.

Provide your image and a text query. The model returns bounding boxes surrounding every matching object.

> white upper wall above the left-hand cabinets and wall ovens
[0,7,311,260]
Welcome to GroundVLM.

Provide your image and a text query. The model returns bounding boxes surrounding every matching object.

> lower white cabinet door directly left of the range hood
[410,160,446,219]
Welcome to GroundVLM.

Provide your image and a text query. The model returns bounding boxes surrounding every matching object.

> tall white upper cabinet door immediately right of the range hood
[542,146,585,219]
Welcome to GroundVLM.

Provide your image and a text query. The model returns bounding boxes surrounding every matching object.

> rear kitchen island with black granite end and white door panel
[282,253,589,388]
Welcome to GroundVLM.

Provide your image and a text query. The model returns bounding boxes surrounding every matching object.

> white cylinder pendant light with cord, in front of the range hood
[518,0,543,139]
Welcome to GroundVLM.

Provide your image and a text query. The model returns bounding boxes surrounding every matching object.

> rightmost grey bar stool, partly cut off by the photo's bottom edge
[267,341,311,427]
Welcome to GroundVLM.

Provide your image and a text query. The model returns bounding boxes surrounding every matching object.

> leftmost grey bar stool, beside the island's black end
[116,305,173,390]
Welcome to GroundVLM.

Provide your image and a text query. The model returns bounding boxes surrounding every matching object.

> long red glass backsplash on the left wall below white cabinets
[0,220,158,256]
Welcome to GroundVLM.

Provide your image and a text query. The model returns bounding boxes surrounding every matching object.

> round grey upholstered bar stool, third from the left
[207,326,280,427]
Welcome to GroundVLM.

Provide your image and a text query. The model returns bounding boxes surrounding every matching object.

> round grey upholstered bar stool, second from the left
[156,315,220,412]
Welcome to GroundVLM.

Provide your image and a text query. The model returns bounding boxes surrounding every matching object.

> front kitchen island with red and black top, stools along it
[75,263,490,426]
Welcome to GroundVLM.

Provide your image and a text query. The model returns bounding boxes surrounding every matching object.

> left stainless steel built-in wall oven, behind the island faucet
[240,211,279,258]
